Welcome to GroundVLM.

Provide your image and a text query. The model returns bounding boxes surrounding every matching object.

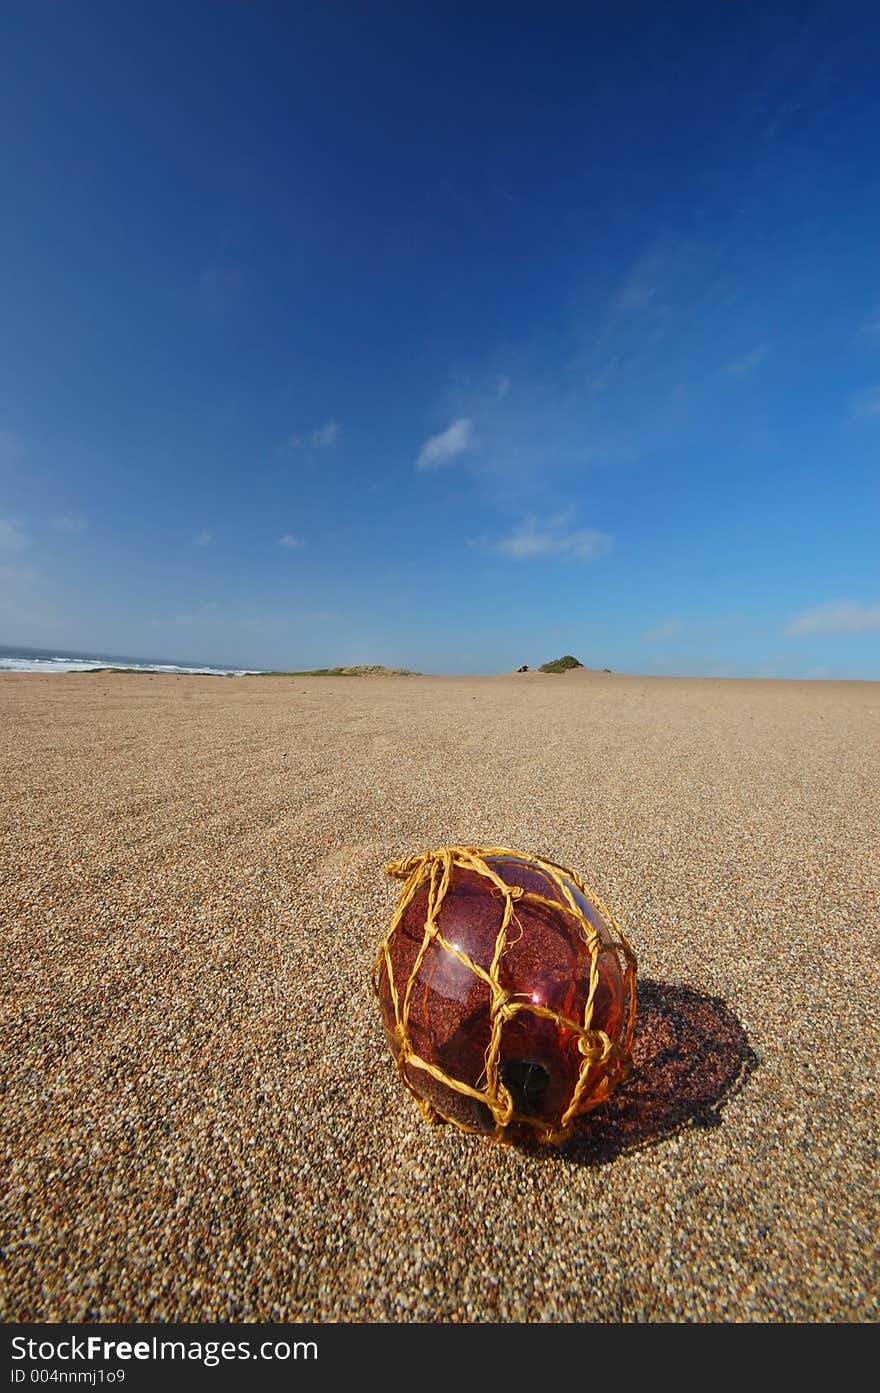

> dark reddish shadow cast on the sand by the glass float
[525,979,757,1166]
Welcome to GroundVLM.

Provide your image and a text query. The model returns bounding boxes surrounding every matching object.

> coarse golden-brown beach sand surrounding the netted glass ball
[0,673,880,1322]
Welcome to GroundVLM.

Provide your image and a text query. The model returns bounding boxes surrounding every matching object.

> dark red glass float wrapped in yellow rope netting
[373,848,635,1142]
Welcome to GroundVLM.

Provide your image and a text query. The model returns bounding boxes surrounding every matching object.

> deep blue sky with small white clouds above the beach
[0,0,880,680]
